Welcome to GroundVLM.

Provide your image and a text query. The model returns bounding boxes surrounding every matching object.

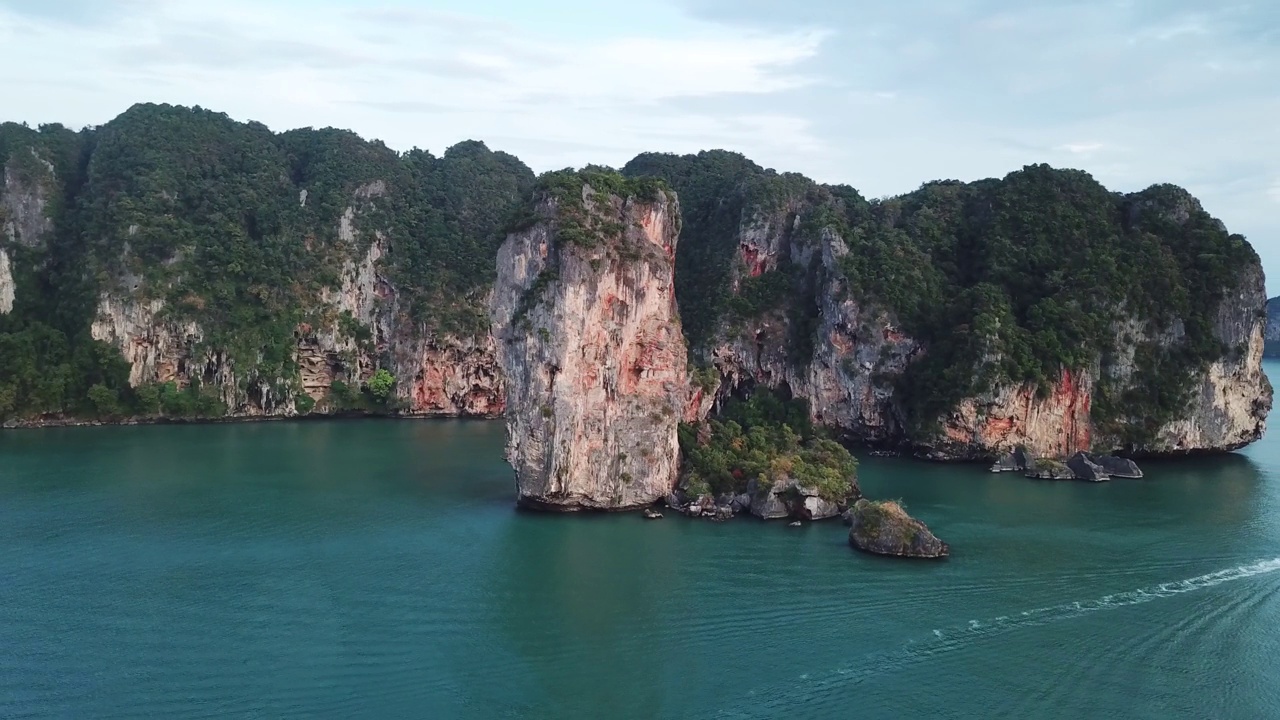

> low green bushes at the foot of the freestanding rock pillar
[680,389,858,501]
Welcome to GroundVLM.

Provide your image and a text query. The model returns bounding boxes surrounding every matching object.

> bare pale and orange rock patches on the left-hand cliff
[91,182,503,418]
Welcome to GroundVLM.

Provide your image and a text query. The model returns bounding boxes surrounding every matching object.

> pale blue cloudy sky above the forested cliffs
[0,0,1280,295]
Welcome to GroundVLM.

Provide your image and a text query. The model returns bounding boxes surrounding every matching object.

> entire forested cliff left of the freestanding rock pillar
[0,105,524,424]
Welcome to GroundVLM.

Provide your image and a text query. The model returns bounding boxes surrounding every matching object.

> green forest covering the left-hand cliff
[0,105,534,421]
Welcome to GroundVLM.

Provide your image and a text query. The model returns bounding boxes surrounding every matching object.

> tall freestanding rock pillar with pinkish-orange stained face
[492,183,690,510]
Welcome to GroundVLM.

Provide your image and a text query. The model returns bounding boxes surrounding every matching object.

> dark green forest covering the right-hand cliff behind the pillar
[623,151,1258,443]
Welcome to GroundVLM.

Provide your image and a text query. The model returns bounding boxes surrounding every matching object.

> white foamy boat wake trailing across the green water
[719,557,1280,717]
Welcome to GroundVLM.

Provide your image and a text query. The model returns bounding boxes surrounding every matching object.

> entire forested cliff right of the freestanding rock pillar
[628,154,1271,460]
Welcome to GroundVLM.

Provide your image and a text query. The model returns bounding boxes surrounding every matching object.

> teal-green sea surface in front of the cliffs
[0,364,1280,720]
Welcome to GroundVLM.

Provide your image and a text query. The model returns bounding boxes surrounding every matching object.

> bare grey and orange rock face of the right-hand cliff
[670,167,1271,460]
